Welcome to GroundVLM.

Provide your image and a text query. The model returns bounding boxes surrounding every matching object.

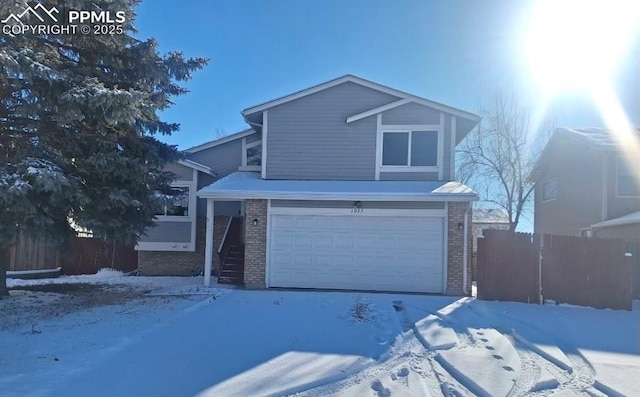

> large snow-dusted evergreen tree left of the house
[0,0,207,296]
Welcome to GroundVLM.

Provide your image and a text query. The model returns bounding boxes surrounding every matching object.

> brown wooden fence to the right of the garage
[478,230,640,310]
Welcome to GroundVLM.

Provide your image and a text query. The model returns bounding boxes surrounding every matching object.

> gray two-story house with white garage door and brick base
[138,75,479,294]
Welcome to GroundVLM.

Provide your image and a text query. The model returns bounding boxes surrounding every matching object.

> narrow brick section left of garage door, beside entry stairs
[244,200,267,288]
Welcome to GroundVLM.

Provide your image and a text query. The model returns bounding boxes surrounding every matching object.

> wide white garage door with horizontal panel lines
[269,214,444,293]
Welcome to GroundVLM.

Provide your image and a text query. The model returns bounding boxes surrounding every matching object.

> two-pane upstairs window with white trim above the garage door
[382,131,438,167]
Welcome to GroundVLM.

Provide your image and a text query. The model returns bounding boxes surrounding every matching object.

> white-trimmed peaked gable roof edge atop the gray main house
[242,74,480,122]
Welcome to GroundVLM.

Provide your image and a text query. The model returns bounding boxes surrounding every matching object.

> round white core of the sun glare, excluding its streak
[526,0,640,95]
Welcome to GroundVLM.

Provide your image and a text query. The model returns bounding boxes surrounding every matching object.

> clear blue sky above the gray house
[136,0,640,149]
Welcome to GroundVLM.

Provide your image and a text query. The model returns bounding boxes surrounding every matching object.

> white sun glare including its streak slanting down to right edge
[526,0,640,194]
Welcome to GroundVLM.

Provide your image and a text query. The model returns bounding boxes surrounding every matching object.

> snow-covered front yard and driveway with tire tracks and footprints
[0,271,640,396]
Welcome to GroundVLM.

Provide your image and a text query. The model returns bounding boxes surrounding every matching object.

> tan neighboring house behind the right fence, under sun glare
[532,128,640,241]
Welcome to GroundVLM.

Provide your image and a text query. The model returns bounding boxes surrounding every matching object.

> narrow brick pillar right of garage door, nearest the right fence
[446,202,473,295]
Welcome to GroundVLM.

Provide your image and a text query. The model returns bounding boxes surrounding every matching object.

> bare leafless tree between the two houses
[456,91,552,231]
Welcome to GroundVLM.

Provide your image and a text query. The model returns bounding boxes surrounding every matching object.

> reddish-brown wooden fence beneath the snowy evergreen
[0,237,138,275]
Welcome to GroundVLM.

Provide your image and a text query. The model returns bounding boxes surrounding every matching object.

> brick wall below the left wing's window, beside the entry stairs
[138,216,229,276]
